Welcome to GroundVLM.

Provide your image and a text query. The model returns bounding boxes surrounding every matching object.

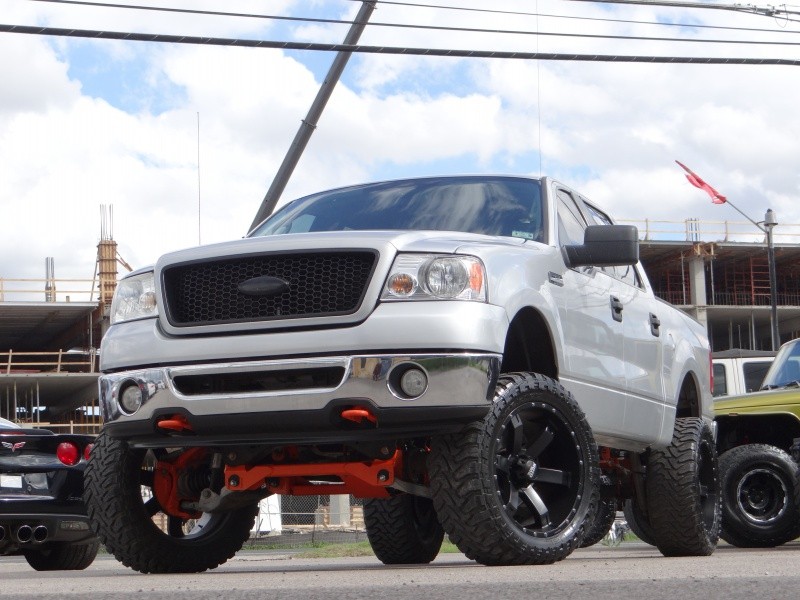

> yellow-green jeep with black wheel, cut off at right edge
[715,340,800,548]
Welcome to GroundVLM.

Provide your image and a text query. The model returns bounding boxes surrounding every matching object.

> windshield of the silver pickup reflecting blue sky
[251,176,545,242]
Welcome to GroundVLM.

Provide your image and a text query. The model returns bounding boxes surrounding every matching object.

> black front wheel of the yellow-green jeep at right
[719,444,800,548]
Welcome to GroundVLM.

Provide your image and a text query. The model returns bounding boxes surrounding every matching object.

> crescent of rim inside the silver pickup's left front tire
[139,449,226,542]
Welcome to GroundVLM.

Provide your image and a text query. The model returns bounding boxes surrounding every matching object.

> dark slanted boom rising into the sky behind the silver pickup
[250,0,377,231]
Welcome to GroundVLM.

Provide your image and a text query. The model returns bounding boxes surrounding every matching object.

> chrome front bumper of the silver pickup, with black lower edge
[100,353,501,440]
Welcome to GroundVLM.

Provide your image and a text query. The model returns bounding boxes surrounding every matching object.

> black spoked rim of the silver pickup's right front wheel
[494,402,583,537]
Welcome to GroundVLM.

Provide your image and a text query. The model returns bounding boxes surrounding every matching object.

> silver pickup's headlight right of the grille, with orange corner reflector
[381,254,486,302]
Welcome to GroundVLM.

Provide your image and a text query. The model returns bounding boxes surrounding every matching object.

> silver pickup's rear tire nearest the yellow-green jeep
[645,417,721,556]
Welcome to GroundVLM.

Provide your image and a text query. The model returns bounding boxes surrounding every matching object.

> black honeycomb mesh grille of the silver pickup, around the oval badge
[162,251,377,327]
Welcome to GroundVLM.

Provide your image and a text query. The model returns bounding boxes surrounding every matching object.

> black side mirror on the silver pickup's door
[564,225,639,267]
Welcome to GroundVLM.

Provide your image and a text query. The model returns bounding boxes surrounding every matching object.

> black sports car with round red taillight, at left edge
[0,419,100,571]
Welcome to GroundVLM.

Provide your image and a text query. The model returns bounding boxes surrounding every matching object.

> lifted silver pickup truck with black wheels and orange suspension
[85,176,720,572]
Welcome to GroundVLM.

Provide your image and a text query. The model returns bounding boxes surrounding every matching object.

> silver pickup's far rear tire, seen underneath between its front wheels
[364,494,444,565]
